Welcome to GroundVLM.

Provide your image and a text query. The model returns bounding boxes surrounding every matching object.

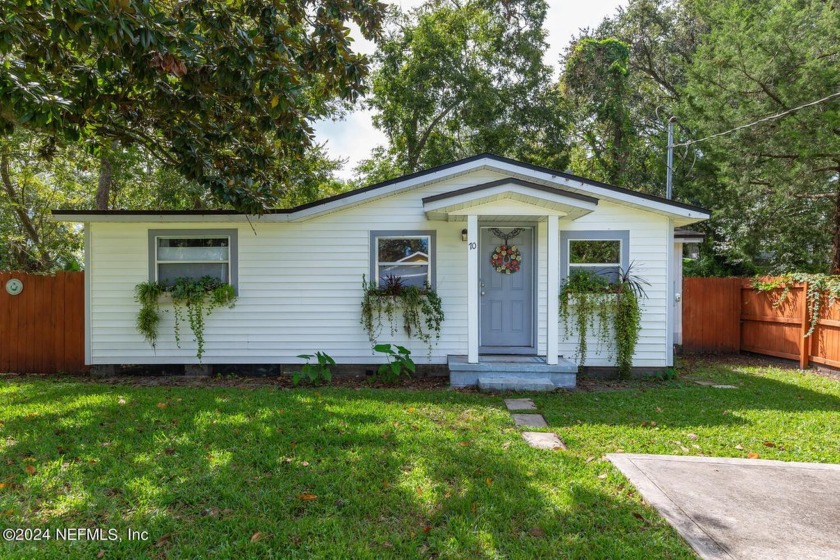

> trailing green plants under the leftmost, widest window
[134,276,236,360]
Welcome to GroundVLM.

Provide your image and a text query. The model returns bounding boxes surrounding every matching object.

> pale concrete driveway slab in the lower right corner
[607,453,840,560]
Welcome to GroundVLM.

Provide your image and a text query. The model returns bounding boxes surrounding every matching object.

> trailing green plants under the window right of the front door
[559,265,647,378]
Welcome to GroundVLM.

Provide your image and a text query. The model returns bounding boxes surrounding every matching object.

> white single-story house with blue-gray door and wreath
[54,155,709,390]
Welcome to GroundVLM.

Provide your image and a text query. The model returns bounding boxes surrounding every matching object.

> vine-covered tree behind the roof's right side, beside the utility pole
[561,0,709,195]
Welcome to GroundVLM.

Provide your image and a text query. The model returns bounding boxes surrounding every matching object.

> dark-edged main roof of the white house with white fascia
[53,154,711,223]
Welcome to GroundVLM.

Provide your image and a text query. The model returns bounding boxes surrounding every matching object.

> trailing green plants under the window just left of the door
[360,276,444,356]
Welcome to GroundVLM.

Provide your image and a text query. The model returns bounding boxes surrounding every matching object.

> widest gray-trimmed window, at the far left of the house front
[149,229,237,287]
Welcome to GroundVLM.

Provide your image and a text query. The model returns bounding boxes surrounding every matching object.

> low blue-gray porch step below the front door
[447,355,578,391]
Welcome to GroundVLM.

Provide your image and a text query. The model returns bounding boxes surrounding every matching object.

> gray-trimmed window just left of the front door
[371,231,435,287]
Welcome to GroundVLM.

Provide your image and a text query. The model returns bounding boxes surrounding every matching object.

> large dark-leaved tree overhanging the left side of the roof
[0,0,384,212]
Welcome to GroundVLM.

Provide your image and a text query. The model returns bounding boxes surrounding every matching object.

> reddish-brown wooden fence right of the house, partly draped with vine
[682,278,840,368]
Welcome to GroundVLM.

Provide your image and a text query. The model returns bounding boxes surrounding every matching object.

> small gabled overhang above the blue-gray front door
[423,178,598,222]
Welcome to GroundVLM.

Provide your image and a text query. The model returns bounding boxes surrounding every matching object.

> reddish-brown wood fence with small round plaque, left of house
[0,272,87,373]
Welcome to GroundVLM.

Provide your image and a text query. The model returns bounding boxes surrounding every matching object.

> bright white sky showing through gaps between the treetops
[315,0,627,179]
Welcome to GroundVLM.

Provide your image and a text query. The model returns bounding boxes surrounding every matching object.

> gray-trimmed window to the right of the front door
[560,231,630,282]
